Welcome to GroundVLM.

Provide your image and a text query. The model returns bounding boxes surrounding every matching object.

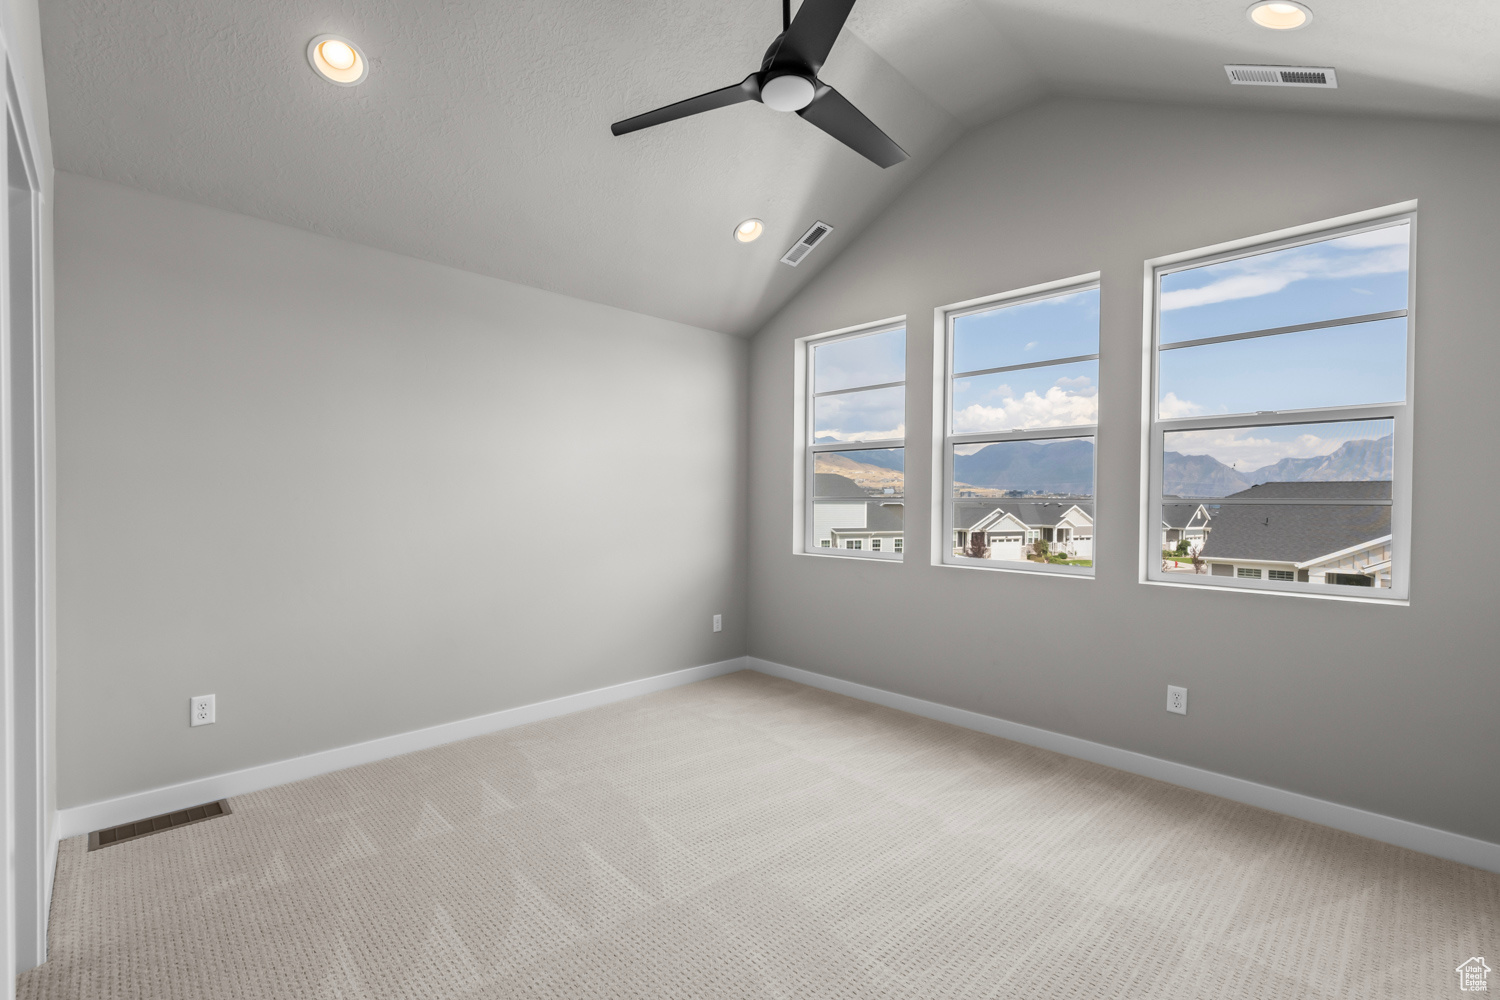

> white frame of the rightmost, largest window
[1140,201,1418,606]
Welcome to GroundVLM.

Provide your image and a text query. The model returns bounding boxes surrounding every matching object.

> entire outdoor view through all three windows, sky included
[810,222,1410,588]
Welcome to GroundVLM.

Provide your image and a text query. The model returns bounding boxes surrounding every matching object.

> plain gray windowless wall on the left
[57,174,749,807]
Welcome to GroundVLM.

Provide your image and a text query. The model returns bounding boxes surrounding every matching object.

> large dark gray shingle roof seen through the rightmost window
[1203,483,1391,562]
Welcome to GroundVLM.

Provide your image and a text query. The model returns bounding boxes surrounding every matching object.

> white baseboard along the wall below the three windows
[746,657,1500,871]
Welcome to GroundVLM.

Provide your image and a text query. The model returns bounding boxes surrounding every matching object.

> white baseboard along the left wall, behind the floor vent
[53,657,746,839]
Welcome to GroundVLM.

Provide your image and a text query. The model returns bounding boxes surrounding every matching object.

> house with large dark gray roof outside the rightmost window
[1203,481,1391,586]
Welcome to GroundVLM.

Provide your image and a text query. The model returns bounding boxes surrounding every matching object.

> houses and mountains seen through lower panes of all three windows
[813,431,1392,588]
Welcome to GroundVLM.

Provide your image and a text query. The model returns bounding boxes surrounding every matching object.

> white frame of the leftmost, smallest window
[792,316,912,564]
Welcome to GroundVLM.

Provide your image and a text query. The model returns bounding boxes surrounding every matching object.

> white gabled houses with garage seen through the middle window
[953,496,1094,562]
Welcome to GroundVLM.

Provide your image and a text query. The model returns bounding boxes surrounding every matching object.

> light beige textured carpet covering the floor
[20,673,1500,1000]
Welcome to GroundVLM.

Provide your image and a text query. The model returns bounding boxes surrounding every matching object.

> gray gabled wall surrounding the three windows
[750,100,1500,841]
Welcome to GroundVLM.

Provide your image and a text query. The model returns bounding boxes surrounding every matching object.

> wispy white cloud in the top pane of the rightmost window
[1161,236,1409,312]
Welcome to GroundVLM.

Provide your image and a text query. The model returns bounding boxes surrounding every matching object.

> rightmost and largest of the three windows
[1145,211,1416,598]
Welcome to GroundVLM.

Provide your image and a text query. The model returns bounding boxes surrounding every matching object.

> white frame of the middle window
[936,271,1103,580]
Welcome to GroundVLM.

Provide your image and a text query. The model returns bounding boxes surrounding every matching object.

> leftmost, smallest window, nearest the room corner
[798,324,906,559]
